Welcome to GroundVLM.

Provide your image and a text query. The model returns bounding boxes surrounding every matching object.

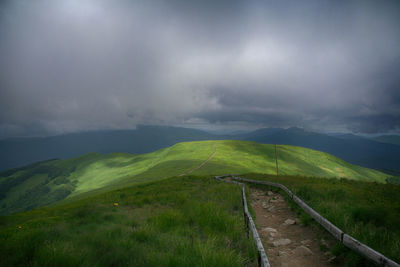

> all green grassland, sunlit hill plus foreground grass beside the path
[0,140,400,266]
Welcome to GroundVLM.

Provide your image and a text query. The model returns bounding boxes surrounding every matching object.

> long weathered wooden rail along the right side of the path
[228,175,400,267]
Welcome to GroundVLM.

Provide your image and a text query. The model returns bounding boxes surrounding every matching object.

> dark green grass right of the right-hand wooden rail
[246,174,400,266]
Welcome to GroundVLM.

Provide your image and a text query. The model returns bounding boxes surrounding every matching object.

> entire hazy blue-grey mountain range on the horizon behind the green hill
[0,126,400,174]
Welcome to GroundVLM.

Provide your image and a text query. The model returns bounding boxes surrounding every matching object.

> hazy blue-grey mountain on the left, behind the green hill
[0,126,220,171]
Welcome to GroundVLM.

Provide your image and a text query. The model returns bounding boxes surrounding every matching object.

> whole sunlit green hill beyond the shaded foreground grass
[0,141,387,214]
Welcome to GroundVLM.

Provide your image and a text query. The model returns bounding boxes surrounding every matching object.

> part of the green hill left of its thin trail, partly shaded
[0,142,213,214]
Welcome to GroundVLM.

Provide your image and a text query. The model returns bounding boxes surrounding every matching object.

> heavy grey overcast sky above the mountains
[0,0,400,138]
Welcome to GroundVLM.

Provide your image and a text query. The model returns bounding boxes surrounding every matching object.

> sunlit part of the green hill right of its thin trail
[194,141,388,182]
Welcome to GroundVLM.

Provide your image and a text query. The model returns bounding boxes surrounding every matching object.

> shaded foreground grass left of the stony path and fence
[0,176,257,266]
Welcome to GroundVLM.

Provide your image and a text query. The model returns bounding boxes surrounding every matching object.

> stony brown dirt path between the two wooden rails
[250,189,339,267]
